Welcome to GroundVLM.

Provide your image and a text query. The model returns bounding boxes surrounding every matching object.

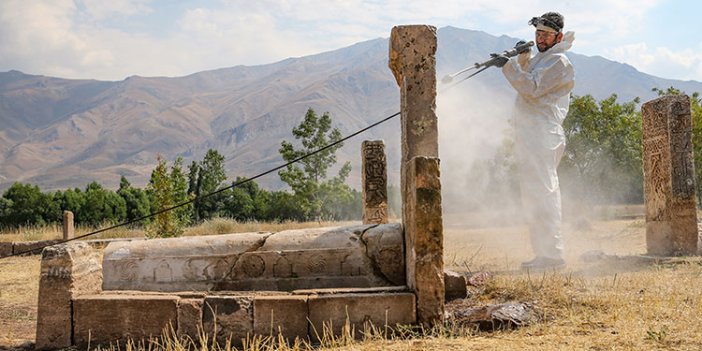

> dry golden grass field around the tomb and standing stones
[0,216,702,350]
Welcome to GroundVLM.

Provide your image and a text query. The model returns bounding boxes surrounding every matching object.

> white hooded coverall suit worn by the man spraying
[502,32,575,259]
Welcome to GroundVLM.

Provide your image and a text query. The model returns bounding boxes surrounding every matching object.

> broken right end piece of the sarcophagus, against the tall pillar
[362,223,407,285]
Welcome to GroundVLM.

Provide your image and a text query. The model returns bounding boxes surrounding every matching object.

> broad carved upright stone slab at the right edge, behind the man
[641,95,700,256]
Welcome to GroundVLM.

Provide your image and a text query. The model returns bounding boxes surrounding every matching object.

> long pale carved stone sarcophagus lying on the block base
[103,225,404,291]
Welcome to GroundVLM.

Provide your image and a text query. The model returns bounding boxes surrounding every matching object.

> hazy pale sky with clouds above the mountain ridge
[0,0,702,81]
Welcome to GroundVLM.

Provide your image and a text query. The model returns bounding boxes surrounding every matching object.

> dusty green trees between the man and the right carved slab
[559,94,643,203]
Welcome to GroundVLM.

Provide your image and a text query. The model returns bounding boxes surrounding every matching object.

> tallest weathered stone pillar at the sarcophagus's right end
[389,25,444,325]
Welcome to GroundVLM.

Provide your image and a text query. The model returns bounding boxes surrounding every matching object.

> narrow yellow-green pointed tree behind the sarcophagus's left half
[146,155,184,237]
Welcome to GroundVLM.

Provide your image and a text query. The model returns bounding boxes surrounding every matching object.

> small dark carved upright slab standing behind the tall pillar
[361,140,388,224]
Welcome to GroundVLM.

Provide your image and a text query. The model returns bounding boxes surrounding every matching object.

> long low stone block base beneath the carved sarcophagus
[72,286,416,347]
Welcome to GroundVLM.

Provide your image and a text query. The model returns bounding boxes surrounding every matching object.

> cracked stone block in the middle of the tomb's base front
[202,296,253,346]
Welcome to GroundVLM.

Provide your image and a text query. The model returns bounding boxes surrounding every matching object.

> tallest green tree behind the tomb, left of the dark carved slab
[278,108,351,220]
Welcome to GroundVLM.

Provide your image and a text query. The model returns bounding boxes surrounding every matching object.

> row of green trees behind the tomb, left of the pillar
[0,109,361,236]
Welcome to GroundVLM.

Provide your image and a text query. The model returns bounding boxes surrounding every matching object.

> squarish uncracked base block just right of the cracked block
[253,295,308,340]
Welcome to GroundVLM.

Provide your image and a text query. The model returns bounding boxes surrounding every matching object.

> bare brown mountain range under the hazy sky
[0,27,702,190]
